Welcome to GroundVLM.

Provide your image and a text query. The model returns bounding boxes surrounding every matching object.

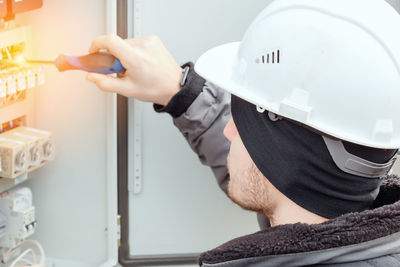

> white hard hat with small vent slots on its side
[195,0,400,149]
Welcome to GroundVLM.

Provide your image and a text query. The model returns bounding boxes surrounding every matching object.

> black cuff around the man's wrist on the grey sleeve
[153,62,206,118]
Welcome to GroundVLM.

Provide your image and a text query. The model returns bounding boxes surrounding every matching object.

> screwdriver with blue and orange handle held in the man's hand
[27,52,125,74]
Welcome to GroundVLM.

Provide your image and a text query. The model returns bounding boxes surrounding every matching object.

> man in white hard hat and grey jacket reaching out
[87,0,400,266]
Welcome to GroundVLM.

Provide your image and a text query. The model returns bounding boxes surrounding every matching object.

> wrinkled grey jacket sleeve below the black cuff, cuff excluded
[174,82,231,196]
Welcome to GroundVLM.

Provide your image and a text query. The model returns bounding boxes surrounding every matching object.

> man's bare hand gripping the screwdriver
[86,35,182,106]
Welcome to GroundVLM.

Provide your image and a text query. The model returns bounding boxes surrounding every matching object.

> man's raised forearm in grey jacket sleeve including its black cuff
[154,64,231,196]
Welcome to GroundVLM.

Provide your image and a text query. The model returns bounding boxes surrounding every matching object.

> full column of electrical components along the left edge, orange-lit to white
[0,0,55,266]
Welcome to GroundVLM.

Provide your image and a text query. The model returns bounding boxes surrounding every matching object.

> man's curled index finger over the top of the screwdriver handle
[89,35,133,59]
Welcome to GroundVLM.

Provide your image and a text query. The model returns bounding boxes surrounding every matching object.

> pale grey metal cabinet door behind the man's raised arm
[121,0,271,266]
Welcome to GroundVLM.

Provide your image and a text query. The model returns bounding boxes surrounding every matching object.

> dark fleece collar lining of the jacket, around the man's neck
[199,176,400,264]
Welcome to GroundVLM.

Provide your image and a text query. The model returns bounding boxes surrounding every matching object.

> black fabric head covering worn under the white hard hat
[231,95,396,219]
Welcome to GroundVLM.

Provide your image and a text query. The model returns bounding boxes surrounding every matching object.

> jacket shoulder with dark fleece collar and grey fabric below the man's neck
[200,176,400,267]
